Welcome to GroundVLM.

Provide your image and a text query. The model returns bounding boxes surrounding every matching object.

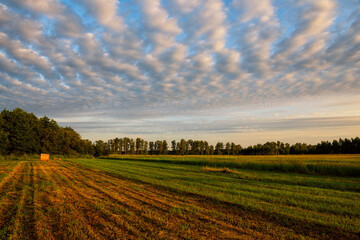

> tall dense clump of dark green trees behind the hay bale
[0,108,94,155]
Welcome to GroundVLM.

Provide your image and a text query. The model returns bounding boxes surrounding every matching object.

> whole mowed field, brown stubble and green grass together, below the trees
[0,155,360,239]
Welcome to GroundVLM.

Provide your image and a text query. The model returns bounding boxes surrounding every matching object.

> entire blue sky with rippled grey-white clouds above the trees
[0,0,360,146]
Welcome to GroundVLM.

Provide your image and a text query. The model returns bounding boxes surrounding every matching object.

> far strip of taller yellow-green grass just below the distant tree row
[103,155,360,177]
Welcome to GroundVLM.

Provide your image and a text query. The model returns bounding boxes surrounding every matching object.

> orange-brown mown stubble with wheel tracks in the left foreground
[0,161,356,239]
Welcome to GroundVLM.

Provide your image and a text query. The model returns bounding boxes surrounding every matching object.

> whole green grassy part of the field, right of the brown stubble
[68,155,360,237]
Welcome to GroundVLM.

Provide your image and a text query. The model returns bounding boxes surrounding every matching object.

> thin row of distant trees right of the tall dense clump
[95,137,360,156]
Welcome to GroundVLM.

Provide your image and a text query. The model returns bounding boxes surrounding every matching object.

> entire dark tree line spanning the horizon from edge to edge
[0,108,360,157]
